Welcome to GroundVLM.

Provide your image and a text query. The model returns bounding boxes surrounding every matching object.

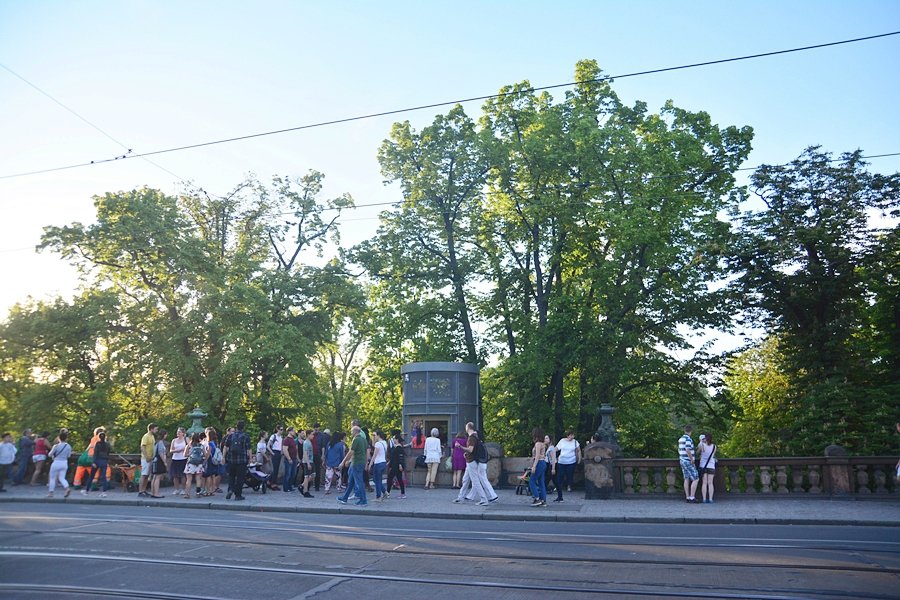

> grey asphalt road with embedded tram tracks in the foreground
[0,504,900,600]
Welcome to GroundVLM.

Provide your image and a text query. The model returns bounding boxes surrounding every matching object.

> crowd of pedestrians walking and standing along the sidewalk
[0,420,724,507]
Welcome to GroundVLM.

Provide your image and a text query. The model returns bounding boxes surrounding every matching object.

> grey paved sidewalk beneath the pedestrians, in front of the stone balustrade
[0,485,900,527]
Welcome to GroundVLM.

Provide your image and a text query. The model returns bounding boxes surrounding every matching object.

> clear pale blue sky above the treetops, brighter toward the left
[0,0,900,344]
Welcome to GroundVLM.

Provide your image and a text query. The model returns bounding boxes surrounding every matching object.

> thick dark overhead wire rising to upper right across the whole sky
[0,31,900,179]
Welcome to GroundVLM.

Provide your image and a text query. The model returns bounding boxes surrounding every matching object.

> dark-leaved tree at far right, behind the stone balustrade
[732,147,900,454]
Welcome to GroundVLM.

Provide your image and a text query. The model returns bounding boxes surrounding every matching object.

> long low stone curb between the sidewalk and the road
[0,497,900,527]
